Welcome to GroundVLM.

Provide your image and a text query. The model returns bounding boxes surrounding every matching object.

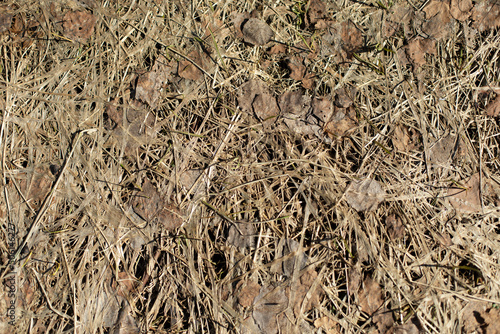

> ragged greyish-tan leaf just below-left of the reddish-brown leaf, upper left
[135,56,172,109]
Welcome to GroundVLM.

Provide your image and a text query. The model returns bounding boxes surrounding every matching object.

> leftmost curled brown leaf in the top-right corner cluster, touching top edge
[422,0,453,40]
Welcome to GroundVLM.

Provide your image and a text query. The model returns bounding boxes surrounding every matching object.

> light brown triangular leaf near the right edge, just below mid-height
[447,173,482,213]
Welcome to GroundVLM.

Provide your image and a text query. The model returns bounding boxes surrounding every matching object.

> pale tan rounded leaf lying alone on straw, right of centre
[345,179,385,212]
